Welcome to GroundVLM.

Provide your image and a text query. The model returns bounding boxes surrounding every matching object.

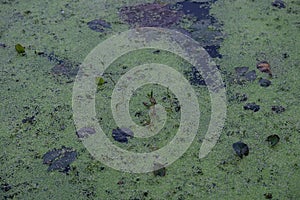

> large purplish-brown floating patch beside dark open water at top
[119,3,183,28]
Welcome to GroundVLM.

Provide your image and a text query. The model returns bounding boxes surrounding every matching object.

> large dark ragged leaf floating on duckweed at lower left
[43,146,77,173]
